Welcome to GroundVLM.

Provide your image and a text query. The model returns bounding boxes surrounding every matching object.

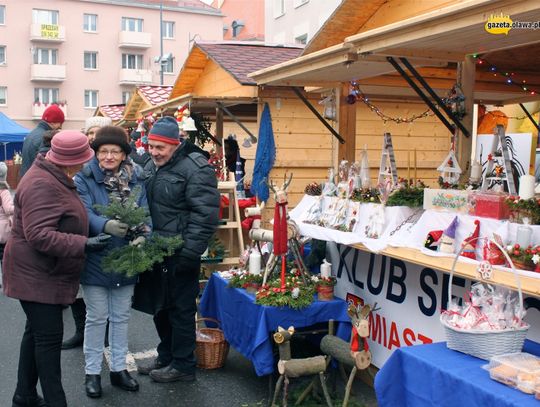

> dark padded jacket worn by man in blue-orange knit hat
[145,140,220,261]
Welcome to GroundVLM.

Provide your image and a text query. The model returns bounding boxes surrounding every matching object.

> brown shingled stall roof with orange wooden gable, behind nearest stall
[170,42,302,99]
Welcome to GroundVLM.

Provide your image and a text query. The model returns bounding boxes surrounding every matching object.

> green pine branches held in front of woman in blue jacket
[95,187,183,277]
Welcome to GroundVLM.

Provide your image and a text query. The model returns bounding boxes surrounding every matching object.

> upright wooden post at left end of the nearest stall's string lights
[337,83,357,163]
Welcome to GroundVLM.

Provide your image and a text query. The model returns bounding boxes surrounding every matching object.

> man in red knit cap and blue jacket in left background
[19,105,64,177]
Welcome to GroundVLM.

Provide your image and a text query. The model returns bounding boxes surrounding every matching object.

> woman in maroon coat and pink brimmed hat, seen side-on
[2,131,109,407]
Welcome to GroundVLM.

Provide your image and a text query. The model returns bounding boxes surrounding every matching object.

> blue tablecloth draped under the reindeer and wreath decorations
[199,274,350,376]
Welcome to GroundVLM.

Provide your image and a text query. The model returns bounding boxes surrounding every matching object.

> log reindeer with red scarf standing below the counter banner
[321,304,377,407]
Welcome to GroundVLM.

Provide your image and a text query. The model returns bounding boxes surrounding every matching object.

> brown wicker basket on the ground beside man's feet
[195,318,229,369]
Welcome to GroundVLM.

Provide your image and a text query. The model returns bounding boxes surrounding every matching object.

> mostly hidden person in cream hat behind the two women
[61,116,112,350]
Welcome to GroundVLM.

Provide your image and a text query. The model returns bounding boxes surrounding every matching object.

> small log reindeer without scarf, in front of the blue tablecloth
[272,326,332,407]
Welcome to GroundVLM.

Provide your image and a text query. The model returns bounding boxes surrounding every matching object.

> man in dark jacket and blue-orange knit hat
[133,117,219,382]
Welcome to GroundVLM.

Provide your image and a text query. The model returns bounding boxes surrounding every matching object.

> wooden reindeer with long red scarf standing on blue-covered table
[263,173,307,290]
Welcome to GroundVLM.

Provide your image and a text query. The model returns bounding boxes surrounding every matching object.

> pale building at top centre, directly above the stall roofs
[264,0,341,44]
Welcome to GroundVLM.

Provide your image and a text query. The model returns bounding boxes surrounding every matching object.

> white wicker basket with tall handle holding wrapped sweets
[440,239,529,360]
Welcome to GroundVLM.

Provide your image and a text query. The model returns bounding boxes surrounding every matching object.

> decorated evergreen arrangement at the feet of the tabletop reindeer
[255,269,315,309]
